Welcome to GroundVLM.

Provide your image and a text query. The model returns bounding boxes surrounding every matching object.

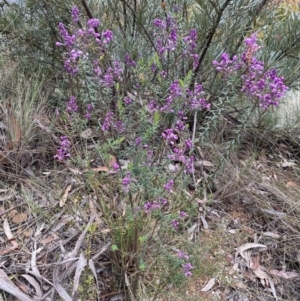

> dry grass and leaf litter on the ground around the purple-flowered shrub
[0,57,300,301]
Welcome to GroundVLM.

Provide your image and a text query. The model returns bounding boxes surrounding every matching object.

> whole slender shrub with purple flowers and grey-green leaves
[55,7,288,292]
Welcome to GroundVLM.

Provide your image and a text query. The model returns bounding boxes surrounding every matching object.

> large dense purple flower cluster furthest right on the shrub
[213,34,288,109]
